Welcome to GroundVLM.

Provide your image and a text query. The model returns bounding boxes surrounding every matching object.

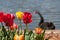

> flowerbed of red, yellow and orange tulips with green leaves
[0,11,48,40]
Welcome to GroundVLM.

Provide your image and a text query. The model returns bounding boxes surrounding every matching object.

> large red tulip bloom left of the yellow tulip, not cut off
[3,14,15,26]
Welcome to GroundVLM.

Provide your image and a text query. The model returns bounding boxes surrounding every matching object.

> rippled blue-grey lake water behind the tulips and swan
[0,0,60,29]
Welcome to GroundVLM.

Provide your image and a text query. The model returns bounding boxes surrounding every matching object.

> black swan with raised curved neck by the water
[35,11,55,30]
